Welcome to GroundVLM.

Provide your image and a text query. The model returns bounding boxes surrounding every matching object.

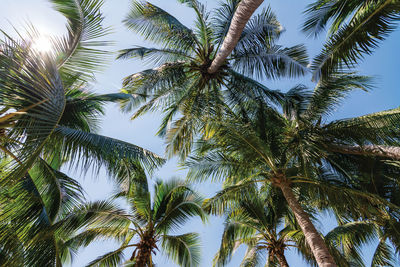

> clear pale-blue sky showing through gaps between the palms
[0,0,400,267]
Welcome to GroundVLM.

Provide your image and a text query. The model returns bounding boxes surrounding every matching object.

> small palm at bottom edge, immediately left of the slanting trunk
[211,190,292,266]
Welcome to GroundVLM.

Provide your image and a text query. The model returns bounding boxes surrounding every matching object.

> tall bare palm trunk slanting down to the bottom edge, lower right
[278,182,336,267]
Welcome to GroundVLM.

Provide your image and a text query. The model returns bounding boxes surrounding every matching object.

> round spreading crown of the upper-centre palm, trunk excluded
[118,0,308,159]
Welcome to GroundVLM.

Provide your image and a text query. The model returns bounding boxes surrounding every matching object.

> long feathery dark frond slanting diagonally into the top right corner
[311,0,400,80]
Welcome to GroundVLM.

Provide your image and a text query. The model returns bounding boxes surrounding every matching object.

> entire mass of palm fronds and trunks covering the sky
[0,0,400,267]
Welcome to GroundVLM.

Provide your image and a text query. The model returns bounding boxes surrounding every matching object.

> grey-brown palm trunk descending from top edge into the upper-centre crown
[208,0,264,73]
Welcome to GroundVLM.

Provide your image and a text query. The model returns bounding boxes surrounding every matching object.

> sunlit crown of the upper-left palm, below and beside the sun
[0,0,162,184]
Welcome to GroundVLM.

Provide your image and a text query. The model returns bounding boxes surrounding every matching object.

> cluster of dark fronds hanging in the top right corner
[303,0,400,80]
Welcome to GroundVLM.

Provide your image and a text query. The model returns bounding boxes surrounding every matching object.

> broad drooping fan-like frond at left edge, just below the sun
[0,36,65,182]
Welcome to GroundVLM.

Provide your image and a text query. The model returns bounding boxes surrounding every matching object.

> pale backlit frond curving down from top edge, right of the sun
[50,0,110,79]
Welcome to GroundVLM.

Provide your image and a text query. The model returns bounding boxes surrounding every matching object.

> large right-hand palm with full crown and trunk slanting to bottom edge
[187,74,400,266]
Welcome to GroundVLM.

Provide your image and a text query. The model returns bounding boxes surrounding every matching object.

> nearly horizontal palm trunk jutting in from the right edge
[329,145,400,160]
